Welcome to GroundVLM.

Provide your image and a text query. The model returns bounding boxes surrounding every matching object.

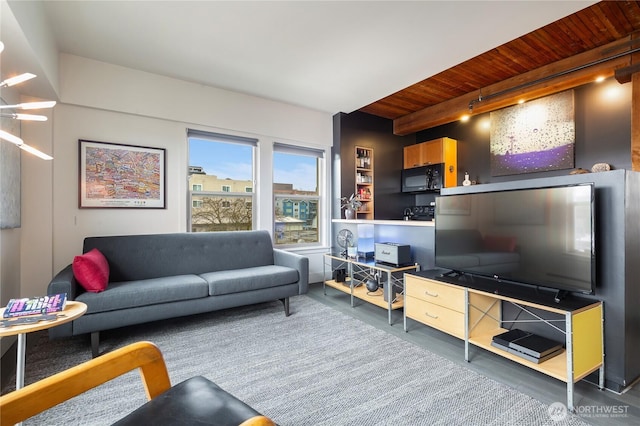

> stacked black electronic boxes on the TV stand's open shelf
[491,328,563,364]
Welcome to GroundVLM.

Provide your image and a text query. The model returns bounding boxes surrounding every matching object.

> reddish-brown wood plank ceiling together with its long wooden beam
[360,1,640,134]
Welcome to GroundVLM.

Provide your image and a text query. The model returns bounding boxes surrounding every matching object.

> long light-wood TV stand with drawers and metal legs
[404,274,604,410]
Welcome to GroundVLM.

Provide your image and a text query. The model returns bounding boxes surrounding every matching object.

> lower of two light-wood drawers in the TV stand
[404,296,464,339]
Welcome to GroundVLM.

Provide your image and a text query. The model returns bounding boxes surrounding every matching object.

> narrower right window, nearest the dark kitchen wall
[273,143,324,245]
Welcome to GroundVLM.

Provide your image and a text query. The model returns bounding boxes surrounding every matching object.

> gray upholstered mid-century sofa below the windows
[47,231,309,356]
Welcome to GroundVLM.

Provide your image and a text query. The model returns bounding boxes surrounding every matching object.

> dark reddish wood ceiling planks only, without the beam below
[362,1,640,119]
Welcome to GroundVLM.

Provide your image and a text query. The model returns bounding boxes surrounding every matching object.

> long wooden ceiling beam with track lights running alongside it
[393,37,640,136]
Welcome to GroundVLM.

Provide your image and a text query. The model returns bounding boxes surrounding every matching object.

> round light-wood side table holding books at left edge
[0,300,87,389]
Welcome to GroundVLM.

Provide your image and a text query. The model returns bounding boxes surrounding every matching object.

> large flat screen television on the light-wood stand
[435,183,596,300]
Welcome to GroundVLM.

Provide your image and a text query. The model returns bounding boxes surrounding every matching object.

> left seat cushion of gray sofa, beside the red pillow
[76,275,209,313]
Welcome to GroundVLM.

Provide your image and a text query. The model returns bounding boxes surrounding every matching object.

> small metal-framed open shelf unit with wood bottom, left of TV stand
[322,253,419,325]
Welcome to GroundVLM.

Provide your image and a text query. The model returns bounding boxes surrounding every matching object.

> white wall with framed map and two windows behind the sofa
[28,55,332,294]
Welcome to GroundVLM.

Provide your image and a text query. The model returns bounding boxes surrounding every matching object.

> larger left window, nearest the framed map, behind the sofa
[187,130,257,232]
